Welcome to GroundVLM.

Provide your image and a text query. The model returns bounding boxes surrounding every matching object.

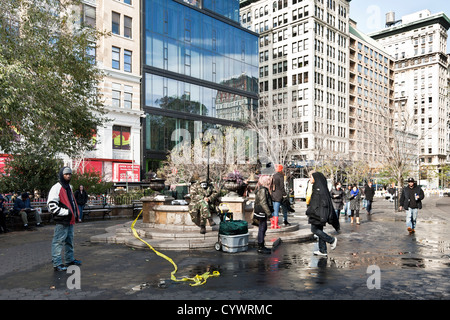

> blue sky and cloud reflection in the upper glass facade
[145,0,258,94]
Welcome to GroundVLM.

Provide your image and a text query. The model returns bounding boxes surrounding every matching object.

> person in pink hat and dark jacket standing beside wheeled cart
[253,175,273,254]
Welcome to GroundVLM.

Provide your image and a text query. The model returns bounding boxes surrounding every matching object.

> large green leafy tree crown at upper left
[0,0,108,158]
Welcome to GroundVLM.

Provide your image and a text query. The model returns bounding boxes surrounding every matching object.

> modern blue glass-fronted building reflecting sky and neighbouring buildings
[142,0,258,170]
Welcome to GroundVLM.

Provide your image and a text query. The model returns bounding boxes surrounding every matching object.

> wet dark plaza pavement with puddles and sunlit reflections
[0,197,450,308]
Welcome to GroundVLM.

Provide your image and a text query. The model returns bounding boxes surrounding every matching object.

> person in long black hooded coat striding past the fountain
[306,172,340,256]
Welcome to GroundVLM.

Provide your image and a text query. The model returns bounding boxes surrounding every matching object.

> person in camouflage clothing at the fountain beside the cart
[189,181,218,234]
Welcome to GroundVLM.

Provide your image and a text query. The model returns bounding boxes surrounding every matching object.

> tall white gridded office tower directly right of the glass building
[241,0,350,168]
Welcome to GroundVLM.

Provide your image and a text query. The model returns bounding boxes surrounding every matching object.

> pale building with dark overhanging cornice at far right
[370,10,450,187]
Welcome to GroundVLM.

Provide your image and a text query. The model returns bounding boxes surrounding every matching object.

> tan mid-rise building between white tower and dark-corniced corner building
[349,20,394,169]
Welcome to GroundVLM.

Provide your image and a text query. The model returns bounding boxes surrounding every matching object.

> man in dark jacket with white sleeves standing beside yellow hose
[47,167,81,271]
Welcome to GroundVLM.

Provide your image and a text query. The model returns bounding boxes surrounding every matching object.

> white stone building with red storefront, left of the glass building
[73,0,143,182]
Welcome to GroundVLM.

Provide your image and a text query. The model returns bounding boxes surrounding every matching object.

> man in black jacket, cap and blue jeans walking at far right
[399,178,425,234]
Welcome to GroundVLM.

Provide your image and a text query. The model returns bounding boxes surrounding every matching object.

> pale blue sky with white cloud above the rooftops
[350,0,450,50]
